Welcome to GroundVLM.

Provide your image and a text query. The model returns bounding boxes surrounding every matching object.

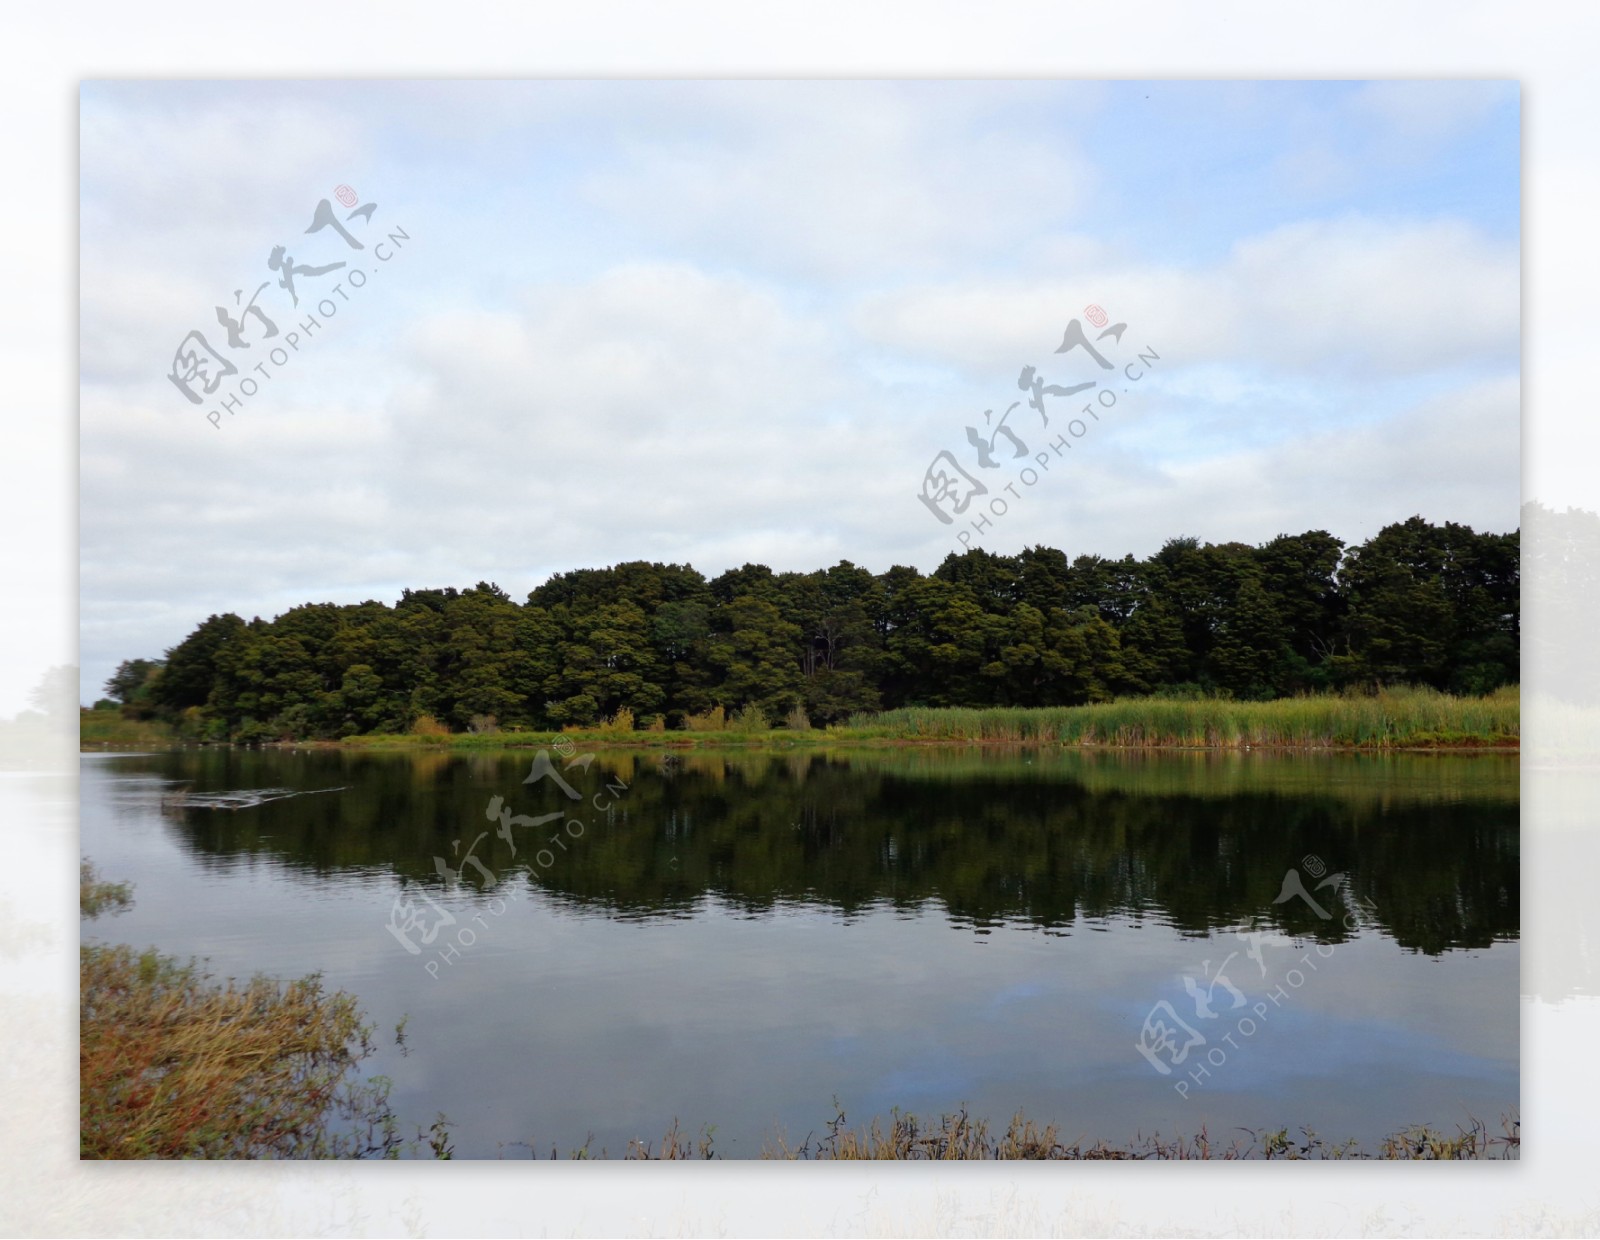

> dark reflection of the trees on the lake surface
[156,752,1520,954]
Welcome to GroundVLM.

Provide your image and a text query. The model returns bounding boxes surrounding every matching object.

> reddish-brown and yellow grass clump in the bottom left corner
[78,862,451,1158]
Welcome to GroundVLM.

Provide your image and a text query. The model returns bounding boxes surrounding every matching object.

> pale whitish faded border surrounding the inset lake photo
[0,0,1600,1235]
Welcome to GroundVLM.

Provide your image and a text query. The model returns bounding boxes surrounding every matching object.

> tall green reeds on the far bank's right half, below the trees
[843,686,1522,749]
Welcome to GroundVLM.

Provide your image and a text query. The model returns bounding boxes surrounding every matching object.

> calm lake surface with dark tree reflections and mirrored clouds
[82,749,1518,1157]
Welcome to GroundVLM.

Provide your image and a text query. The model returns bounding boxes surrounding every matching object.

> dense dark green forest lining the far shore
[101,517,1520,741]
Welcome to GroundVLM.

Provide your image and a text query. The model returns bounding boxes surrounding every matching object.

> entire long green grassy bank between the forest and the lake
[321,686,1522,750]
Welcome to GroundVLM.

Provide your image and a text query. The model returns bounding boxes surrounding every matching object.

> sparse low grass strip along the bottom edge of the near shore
[508,1104,1522,1162]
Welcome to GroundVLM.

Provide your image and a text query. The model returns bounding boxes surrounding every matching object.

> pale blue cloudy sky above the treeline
[80,82,1520,701]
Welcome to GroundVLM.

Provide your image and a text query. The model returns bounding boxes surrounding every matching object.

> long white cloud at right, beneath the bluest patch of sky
[856,218,1520,376]
